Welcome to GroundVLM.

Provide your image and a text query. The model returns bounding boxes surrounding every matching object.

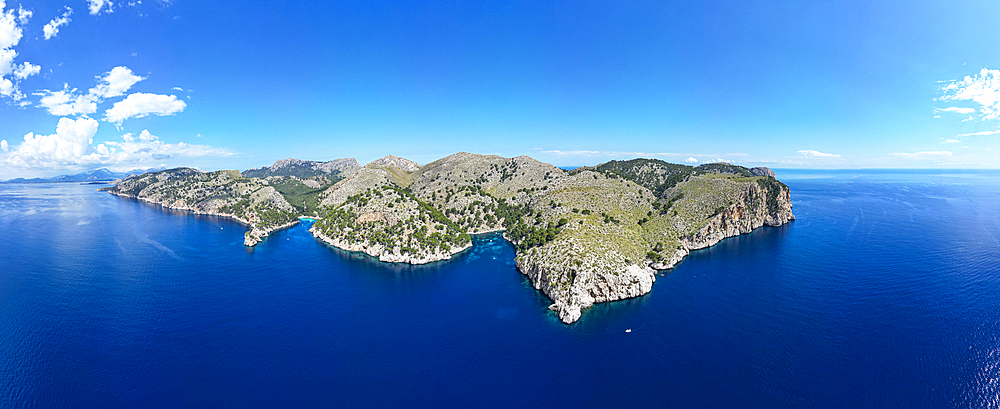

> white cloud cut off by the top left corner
[0,0,40,101]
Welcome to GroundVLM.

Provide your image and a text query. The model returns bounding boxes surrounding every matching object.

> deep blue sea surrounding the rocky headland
[0,171,1000,408]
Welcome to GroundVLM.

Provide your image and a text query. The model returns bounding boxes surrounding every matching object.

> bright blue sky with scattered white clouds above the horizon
[0,0,1000,180]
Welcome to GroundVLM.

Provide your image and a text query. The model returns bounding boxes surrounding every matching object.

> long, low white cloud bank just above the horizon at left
[0,117,235,171]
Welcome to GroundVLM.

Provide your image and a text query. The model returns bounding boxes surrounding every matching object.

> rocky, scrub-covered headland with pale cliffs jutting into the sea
[105,152,795,324]
